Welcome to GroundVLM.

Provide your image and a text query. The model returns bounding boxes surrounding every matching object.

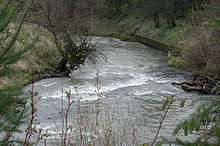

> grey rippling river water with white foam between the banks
[24,38,211,145]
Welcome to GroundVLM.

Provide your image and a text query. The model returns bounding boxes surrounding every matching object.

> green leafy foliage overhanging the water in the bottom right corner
[173,101,220,146]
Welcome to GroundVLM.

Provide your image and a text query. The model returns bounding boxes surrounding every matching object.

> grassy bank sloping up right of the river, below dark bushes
[94,0,220,78]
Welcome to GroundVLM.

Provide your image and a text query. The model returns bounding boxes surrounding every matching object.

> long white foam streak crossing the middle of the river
[35,74,154,100]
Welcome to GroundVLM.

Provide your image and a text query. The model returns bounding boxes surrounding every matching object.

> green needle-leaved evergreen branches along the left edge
[0,0,36,145]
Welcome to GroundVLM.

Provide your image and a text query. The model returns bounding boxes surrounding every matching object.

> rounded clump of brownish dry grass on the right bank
[180,28,220,77]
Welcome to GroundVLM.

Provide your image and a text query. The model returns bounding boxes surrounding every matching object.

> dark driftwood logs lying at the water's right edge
[172,74,219,94]
